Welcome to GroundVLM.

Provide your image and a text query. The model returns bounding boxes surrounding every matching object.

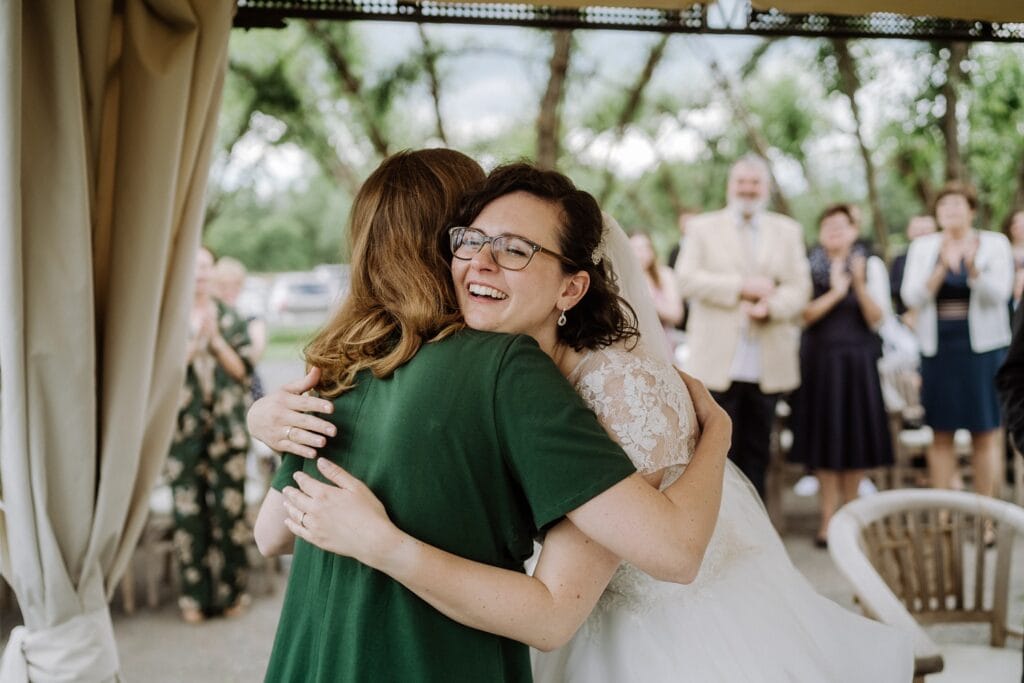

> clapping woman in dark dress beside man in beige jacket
[790,204,893,548]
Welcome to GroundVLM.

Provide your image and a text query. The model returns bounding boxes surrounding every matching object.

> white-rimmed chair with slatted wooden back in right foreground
[828,489,1024,682]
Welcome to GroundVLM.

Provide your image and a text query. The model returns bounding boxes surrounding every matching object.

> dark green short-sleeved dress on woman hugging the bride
[266,330,635,683]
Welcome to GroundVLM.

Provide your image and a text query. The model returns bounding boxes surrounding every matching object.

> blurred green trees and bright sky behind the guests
[205,22,1024,270]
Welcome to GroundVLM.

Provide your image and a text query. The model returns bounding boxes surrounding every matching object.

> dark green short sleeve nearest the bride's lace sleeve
[494,336,636,530]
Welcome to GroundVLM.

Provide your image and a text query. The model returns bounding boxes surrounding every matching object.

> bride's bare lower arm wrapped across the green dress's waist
[285,458,618,651]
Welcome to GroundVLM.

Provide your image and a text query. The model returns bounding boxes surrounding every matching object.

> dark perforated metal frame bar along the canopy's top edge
[234,0,1024,42]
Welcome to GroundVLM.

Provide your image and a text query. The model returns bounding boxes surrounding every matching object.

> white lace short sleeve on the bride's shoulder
[571,347,696,475]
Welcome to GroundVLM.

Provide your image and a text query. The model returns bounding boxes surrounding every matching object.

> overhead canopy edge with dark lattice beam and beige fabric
[234,0,1024,42]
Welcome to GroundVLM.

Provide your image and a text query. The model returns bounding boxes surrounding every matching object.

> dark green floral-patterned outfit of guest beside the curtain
[166,301,253,614]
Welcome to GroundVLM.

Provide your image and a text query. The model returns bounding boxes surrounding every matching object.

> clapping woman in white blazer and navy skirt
[900,182,1014,524]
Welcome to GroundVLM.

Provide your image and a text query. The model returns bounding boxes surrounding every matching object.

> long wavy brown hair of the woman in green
[305,150,484,398]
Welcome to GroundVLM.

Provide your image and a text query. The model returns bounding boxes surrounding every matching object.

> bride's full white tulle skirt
[534,464,913,683]
